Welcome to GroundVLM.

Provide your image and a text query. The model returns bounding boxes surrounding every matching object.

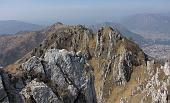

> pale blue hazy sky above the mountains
[0,0,170,24]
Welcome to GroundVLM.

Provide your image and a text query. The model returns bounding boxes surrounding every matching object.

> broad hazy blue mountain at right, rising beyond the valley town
[121,13,170,40]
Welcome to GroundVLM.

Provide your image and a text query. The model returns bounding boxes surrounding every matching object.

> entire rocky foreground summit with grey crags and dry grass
[0,25,170,103]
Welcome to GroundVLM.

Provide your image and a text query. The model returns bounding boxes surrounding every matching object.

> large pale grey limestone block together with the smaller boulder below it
[21,49,96,103]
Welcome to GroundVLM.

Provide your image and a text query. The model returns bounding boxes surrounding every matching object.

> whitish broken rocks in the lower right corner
[141,61,169,103]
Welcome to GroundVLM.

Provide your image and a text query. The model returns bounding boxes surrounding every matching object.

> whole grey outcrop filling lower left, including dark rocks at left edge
[0,49,97,103]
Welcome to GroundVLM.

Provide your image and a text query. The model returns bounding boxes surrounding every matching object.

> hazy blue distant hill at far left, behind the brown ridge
[0,20,44,35]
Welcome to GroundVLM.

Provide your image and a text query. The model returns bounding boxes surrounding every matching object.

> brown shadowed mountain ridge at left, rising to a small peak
[0,23,65,67]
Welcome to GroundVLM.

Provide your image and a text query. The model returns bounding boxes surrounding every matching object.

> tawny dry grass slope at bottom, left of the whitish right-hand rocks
[107,66,147,103]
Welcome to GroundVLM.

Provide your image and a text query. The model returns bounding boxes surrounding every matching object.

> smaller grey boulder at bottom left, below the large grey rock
[21,80,62,103]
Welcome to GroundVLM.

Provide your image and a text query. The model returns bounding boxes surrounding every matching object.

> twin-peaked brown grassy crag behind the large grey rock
[21,25,145,102]
